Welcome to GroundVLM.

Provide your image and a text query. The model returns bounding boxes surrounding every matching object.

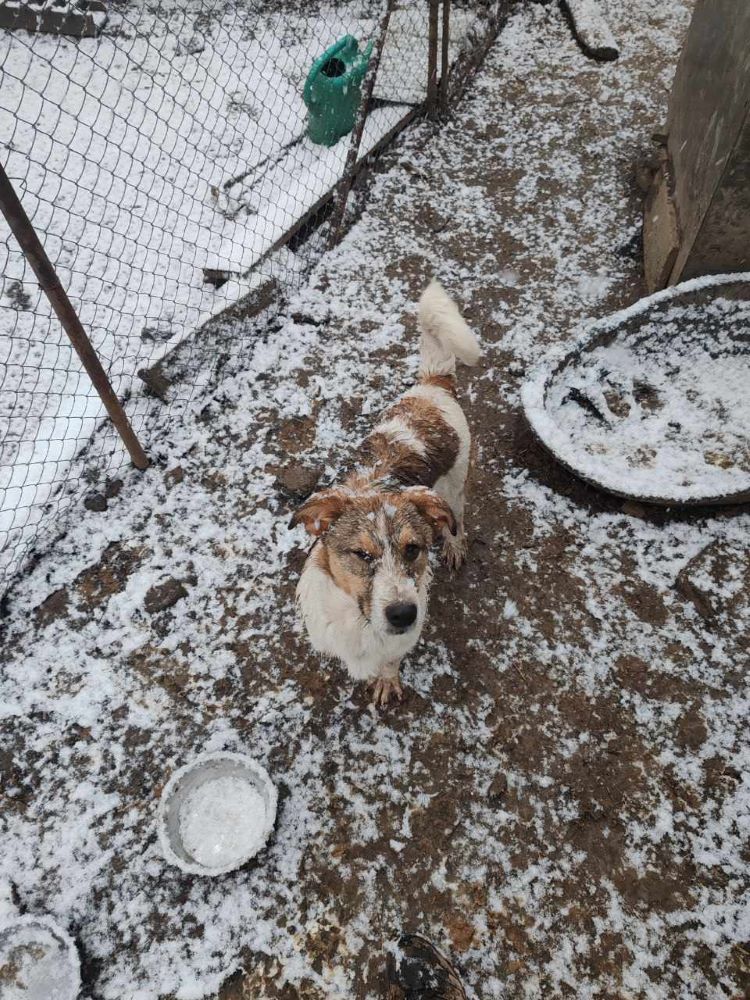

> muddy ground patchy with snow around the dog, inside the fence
[0,0,750,1000]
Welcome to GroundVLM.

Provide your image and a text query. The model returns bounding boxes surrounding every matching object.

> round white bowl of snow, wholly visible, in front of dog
[156,751,277,875]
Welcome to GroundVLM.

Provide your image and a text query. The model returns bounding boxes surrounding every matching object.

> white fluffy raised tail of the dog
[419,280,482,375]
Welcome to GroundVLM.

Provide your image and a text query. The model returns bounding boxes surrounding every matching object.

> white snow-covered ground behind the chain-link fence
[0,0,482,577]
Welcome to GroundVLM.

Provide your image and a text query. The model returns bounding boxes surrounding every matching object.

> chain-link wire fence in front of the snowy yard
[0,0,500,592]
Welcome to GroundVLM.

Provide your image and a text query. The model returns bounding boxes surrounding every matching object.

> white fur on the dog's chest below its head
[297,559,429,680]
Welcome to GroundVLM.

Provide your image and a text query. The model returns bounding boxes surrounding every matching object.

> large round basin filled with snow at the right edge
[522,274,750,505]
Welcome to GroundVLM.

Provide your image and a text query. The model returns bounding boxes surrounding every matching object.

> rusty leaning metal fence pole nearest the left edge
[0,164,149,469]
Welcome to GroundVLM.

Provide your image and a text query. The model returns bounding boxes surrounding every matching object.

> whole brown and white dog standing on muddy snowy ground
[292,281,480,705]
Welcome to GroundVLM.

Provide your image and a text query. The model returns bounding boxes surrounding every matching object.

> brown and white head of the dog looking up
[292,487,456,635]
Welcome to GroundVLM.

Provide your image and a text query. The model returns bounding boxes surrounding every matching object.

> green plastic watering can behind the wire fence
[302,35,374,146]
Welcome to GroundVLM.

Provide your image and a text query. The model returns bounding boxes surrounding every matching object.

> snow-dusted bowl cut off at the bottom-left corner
[0,915,81,1000]
